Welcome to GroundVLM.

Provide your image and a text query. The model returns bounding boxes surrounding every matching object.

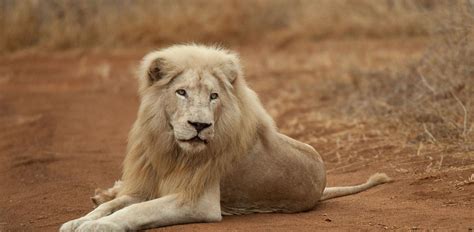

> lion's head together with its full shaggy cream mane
[120,45,275,200]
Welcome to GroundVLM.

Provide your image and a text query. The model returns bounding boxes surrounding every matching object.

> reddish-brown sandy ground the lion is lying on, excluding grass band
[0,39,474,231]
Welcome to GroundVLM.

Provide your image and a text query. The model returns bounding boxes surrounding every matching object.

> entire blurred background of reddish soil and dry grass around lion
[0,0,474,231]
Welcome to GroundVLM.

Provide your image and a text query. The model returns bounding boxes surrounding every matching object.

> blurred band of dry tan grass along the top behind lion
[0,0,452,52]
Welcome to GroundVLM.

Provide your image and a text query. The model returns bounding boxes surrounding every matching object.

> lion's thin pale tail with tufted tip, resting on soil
[321,173,391,201]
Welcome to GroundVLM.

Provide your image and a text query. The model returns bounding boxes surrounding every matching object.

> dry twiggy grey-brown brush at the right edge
[323,3,474,152]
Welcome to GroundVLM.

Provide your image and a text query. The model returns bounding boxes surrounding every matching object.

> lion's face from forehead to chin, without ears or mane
[166,70,225,153]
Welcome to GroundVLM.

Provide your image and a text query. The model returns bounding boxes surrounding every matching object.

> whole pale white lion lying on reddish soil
[60,44,390,232]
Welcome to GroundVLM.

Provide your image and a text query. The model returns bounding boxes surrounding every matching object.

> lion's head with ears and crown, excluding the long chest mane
[139,45,241,153]
